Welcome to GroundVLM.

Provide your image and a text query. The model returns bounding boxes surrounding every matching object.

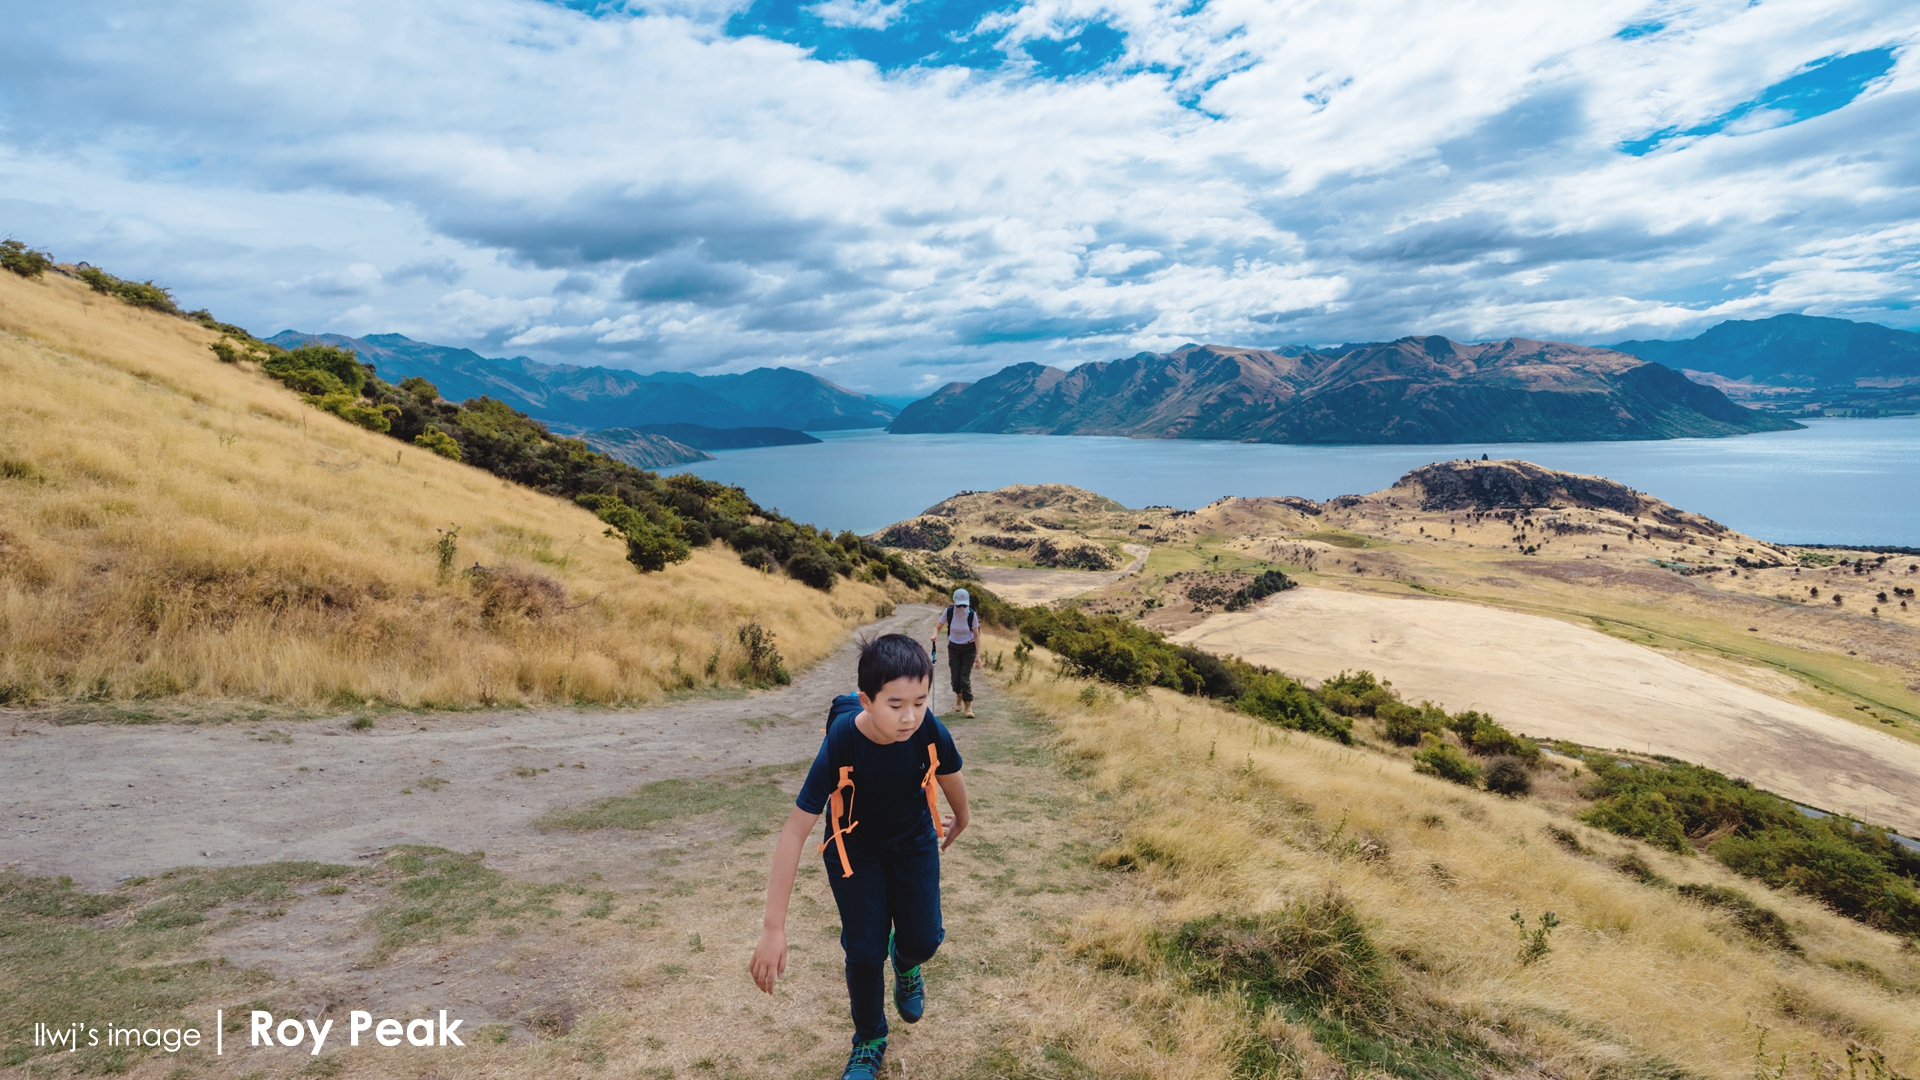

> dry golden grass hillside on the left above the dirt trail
[0,275,883,707]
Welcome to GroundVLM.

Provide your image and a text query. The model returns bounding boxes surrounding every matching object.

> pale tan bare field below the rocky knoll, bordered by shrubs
[1175,588,1920,836]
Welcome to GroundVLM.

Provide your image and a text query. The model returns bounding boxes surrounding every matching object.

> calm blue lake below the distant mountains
[670,417,1920,548]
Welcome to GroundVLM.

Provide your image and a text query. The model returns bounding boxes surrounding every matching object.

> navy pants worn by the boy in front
[826,828,947,1043]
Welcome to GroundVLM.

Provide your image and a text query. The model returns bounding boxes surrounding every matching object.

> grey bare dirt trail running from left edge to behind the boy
[0,605,935,888]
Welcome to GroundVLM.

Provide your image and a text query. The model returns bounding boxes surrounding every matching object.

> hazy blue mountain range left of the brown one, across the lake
[267,331,899,434]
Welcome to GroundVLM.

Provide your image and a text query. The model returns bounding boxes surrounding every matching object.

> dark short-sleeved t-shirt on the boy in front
[793,694,960,847]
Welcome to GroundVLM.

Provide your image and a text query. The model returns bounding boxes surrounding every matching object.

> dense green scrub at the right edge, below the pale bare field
[1584,753,1920,936]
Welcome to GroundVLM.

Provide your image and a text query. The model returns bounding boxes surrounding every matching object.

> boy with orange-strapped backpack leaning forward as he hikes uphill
[749,634,968,1080]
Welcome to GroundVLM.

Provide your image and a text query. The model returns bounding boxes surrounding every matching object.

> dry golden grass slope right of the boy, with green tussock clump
[995,626,1920,1078]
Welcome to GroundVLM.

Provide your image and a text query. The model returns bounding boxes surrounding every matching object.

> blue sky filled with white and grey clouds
[0,0,1920,394]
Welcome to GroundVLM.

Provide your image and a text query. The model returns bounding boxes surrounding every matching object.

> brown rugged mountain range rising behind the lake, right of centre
[889,336,1799,444]
